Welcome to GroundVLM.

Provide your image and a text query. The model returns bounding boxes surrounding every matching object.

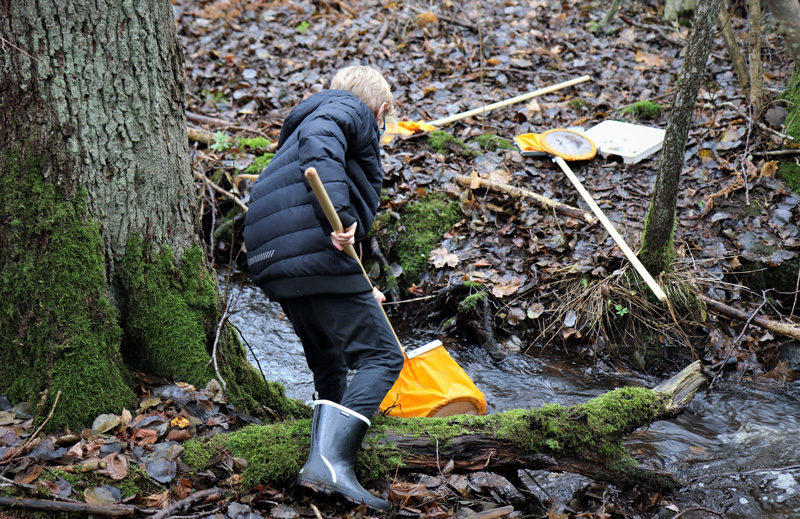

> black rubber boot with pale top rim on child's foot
[295,400,391,510]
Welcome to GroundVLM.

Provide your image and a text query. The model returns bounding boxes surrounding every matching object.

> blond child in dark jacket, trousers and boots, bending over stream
[244,66,403,510]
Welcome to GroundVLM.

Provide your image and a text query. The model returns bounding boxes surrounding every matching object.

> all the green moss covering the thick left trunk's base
[0,154,310,430]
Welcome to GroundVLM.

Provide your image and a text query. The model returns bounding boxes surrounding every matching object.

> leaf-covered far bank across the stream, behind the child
[175,0,800,382]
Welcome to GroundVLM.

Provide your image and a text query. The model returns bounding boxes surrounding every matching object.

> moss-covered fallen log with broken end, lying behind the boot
[184,361,706,492]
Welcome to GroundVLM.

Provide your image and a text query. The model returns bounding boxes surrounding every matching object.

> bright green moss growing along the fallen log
[183,388,665,486]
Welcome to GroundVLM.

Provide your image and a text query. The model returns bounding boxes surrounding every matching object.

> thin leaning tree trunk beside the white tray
[639,0,720,276]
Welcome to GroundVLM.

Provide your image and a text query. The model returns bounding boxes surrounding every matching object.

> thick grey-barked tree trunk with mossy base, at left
[0,0,302,427]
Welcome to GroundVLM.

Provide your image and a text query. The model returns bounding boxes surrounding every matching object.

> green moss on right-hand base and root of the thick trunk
[120,237,310,417]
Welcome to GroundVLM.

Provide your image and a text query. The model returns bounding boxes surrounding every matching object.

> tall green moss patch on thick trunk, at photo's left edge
[0,153,136,430]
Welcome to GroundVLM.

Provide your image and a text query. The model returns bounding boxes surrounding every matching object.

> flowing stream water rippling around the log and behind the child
[231,278,800,519]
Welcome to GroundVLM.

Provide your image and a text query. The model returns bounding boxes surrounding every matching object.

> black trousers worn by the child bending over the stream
[280,292,403,417]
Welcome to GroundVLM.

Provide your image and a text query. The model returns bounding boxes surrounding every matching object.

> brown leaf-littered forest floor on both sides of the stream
[0,0,800,519]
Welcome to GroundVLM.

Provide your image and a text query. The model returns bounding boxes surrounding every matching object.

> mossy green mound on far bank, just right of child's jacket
[375,193,461,284]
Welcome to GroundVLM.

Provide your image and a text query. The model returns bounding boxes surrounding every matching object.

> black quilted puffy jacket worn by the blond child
[244,90,383,301]
